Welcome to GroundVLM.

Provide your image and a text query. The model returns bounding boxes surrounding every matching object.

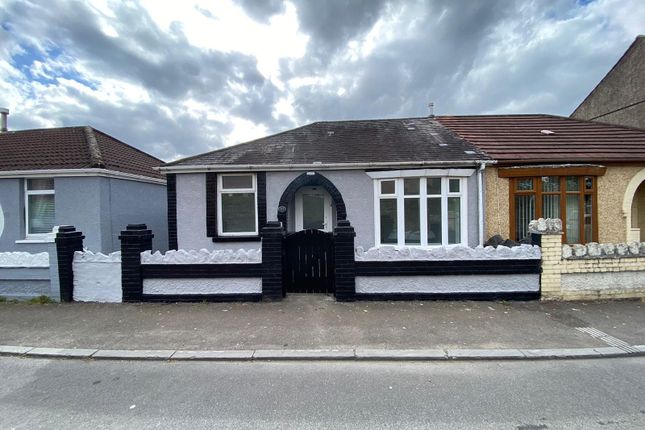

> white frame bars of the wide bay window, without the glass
[374,175,468,248]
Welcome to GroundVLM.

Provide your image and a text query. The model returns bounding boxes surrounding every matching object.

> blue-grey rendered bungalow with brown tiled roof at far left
[0,115,168,253]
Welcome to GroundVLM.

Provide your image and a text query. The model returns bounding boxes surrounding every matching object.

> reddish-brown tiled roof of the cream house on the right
[436,115,645,164]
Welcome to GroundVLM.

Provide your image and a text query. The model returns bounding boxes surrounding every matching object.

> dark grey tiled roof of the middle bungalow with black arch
[166,118,487,166]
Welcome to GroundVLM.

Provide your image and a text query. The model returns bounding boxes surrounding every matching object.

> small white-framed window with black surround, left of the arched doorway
[217,174,258,236]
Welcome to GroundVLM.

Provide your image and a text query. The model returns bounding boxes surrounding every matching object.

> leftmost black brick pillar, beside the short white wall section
[55,225,85,302]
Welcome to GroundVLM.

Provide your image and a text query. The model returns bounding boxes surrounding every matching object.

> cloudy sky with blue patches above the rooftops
[0,0,645,161]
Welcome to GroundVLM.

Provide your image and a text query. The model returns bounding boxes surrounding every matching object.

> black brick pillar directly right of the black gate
[334,220,356,302]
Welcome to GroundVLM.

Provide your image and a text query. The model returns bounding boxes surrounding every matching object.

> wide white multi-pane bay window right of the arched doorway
[374,177,467,246]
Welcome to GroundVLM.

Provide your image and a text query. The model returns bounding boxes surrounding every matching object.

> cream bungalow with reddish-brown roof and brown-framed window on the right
[437,115,645,244]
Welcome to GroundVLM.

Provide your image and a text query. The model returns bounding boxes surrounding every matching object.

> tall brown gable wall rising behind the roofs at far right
[571,35,645,129]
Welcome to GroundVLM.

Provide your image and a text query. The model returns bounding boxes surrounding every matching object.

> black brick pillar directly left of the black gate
[262,221,284,300]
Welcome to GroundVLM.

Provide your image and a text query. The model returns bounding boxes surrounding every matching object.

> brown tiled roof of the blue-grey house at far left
[0,127,163,179]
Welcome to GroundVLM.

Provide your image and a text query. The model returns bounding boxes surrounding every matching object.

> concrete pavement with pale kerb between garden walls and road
[0,295,645,360]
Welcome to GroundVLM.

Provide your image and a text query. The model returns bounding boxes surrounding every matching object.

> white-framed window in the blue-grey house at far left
[25,178,56,237]
